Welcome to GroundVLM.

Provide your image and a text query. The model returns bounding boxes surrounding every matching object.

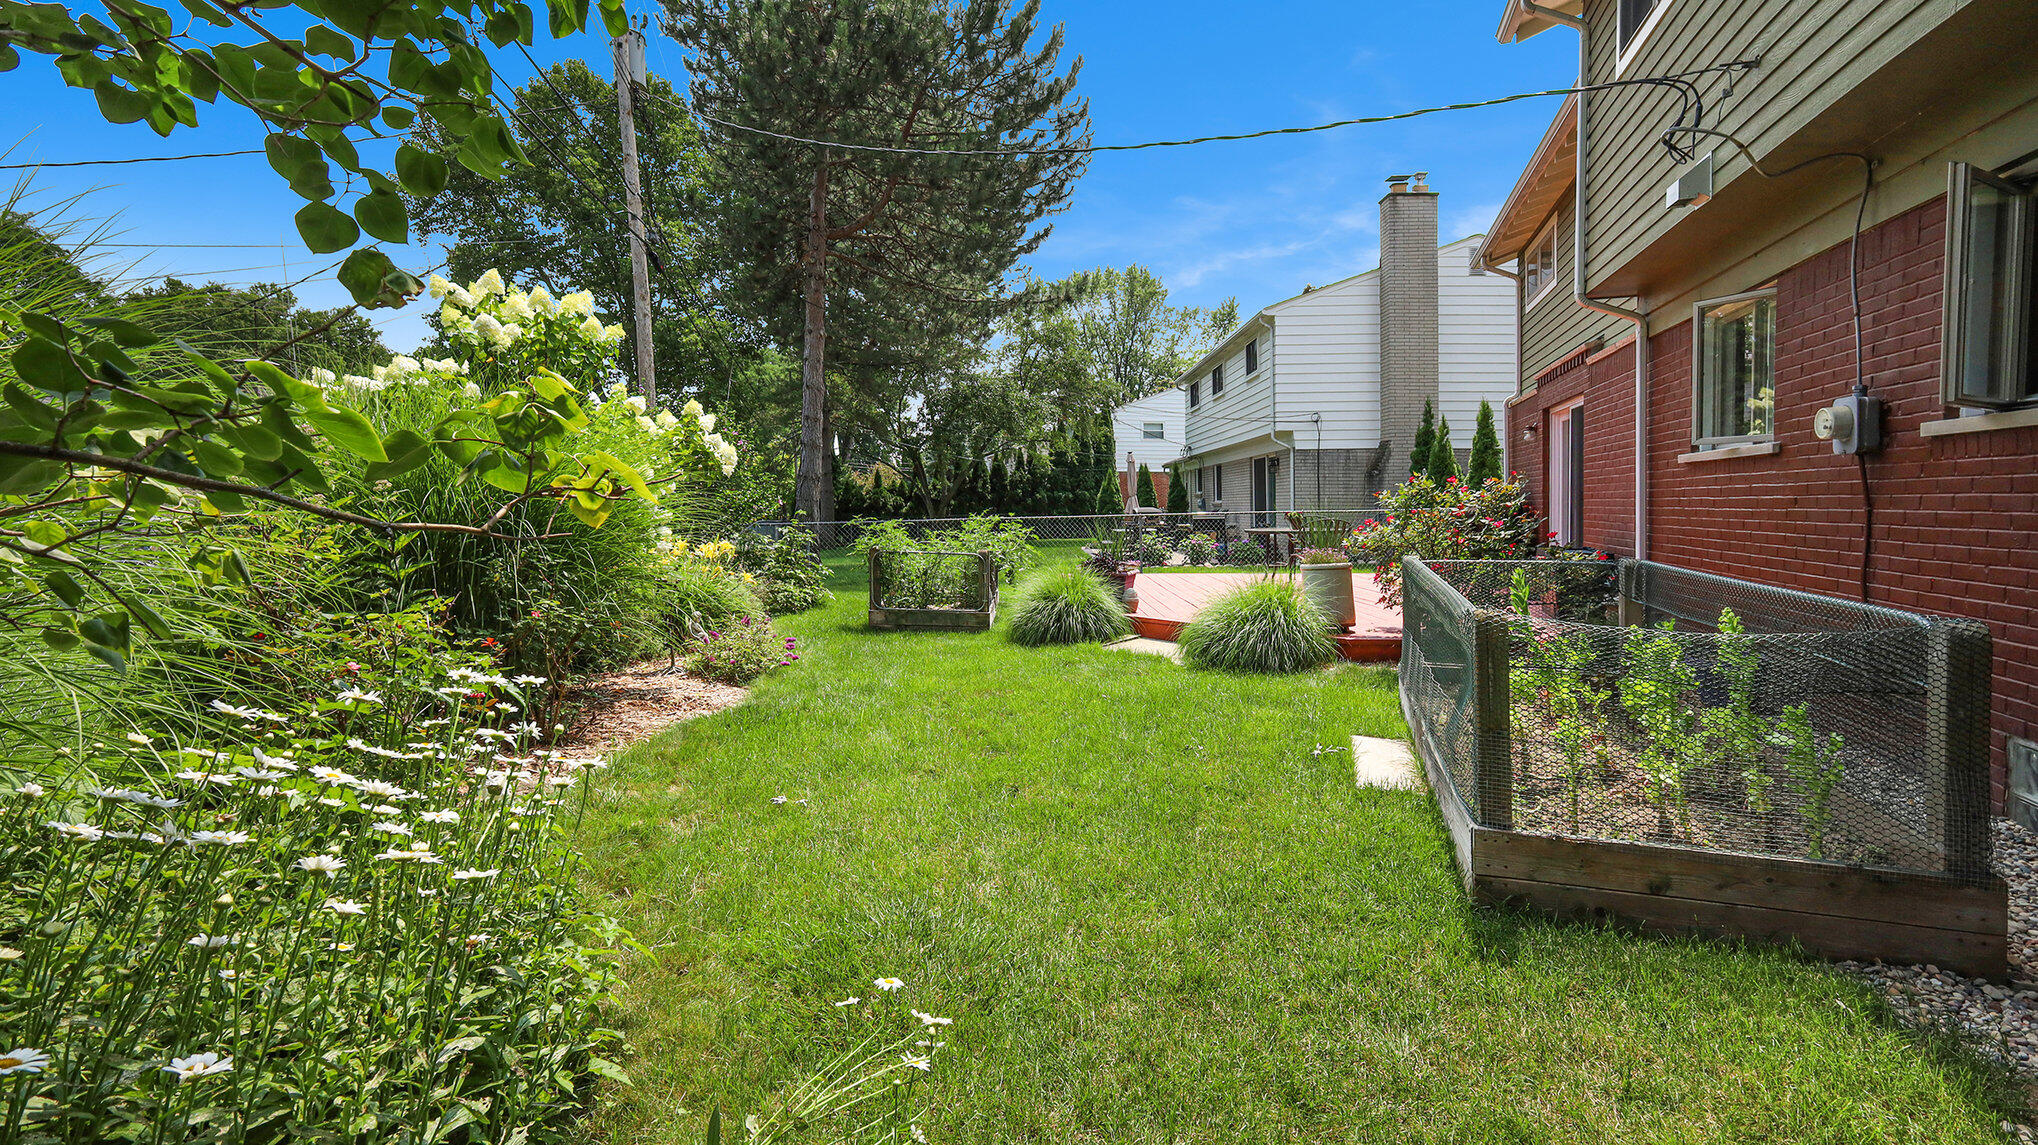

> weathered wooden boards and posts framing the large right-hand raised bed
[1402,558,2009,980]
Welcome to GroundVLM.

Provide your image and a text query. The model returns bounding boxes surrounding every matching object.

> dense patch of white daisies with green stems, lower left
[0,668,622,1141]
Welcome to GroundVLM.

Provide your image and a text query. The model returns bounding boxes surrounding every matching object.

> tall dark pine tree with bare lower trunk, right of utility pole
[664,0,1090,513]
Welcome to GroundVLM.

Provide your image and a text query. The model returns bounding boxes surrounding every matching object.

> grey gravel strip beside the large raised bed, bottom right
[1838,819,2038,1100]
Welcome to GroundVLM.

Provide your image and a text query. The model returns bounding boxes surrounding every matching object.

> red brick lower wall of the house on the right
[1508,200,2038,805]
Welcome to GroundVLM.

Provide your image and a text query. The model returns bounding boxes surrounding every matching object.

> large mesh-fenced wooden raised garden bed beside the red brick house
[1402,558,2007,978]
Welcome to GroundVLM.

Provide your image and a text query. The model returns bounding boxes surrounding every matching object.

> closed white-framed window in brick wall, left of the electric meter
[1692,289,1777,448]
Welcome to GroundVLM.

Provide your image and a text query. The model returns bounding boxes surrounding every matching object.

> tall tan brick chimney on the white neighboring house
[1380,171,1437,464]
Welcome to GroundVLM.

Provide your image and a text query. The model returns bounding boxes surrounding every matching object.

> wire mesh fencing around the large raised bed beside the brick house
[1400,556,1989,882]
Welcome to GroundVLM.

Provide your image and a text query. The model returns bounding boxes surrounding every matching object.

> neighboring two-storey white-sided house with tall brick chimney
[1165,175,1514,524]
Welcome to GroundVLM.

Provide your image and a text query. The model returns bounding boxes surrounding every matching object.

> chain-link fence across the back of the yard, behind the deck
[750,509,1378,566]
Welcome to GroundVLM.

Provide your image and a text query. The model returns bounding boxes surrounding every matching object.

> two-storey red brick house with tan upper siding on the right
[1480,0,2038,811]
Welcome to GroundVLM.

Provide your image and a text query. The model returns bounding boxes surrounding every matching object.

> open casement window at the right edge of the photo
[1940,163,2038,410]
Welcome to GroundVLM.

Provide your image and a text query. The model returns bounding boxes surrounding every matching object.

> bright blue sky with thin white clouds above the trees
[0,0,1577,350]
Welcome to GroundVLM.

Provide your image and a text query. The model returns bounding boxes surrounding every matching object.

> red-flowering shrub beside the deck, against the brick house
[1345,475,1543,605]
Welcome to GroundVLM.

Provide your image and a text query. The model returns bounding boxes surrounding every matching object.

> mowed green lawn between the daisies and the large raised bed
[581,558,2022,1145]
